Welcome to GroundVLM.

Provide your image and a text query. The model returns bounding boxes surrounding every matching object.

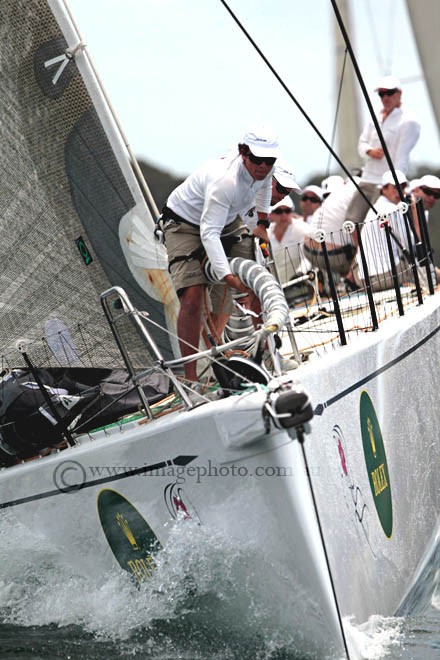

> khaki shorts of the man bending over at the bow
[164,216,254,311]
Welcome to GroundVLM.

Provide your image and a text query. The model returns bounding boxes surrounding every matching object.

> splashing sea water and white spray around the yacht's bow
[0,515,440,660]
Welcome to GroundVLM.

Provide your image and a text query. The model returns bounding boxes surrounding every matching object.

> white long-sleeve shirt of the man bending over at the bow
[167,154,273,279]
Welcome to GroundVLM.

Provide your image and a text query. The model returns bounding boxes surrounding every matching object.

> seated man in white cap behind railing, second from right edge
[353,170,412,291]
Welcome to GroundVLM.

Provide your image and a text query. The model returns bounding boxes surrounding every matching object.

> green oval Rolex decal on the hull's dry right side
[360,391,393,538]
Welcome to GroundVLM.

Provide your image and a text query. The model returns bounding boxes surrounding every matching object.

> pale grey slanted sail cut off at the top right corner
[406,0,440,128]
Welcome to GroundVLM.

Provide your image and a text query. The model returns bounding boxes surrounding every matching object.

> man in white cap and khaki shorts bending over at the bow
[162,126,279,381]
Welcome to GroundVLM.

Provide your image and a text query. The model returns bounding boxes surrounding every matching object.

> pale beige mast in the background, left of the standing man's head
[332,0,362,173]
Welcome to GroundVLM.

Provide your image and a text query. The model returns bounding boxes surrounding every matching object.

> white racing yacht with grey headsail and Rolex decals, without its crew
[0,0,440,658]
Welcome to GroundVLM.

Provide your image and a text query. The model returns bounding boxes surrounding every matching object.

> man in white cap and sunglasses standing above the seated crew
[346,76,420,223]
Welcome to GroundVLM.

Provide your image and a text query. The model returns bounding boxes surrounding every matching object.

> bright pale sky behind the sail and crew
[68,0,440,185]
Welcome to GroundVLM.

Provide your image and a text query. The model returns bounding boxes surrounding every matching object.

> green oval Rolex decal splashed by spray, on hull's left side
[98,489,160,582]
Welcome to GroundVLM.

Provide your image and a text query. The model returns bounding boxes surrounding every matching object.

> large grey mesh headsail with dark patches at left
[0,0,178,366]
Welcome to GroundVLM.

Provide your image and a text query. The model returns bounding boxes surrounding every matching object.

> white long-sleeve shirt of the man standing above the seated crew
[358,106,420,184]
